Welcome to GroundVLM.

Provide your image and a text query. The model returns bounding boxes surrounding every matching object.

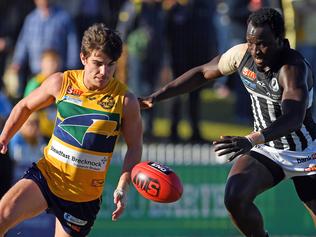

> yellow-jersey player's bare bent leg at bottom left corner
[0,179,47,236]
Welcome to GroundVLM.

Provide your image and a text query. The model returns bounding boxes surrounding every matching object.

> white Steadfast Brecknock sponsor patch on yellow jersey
[48,141,108,172]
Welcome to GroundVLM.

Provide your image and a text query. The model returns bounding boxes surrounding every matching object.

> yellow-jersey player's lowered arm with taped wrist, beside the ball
[112,90,143,220]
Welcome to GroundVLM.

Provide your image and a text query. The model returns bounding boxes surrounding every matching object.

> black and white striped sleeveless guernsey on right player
[238,49,316,151]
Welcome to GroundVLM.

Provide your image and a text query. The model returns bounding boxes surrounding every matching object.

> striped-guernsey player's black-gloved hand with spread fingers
[213,136,254,161]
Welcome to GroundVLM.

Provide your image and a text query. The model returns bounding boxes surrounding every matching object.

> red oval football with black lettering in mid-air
[131,161,183,203]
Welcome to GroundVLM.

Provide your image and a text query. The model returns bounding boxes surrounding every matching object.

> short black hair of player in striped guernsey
[247,7,285,39]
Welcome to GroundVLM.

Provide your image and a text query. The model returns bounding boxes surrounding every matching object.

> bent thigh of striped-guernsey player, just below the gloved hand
[226,153,284,200]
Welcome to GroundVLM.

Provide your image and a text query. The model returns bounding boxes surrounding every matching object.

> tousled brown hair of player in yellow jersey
[81,23,123,61]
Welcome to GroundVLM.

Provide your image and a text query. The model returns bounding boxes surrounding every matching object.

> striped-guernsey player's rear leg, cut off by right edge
[292,175,316,227]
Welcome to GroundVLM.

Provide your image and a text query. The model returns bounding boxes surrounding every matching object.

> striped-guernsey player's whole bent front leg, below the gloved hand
[225,152,284,237]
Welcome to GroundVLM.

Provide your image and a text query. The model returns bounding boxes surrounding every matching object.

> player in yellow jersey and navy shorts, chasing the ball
[0,24,142,237]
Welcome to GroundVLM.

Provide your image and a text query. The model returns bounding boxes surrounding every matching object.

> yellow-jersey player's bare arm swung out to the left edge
[0,73,63,153]
